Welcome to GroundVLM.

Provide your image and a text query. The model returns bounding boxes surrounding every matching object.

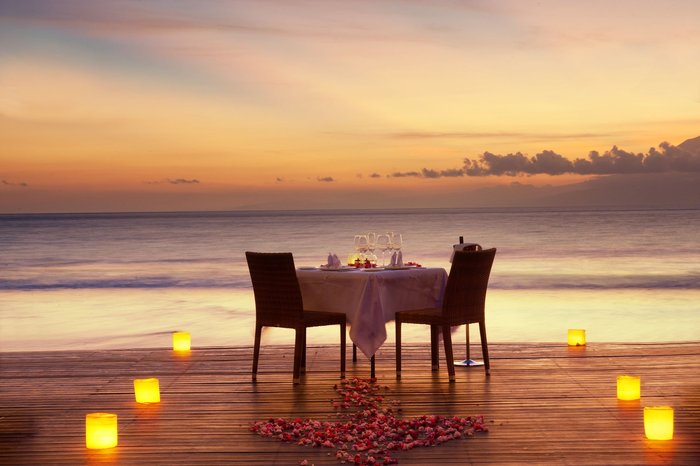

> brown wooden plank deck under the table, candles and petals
[0,342,700,466]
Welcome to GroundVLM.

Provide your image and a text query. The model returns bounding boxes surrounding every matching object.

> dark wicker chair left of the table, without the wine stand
[245,252,345,384]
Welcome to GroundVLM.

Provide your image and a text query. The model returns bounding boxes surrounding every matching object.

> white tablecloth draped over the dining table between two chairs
[297,267,447,357]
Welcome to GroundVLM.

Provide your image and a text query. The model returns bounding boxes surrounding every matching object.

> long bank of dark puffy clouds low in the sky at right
[464,142,700,176]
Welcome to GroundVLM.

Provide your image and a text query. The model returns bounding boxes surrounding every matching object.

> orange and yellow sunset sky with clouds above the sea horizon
[0,0,700,213]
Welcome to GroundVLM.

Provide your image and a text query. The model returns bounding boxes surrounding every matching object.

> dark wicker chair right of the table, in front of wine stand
[396,248,496,382]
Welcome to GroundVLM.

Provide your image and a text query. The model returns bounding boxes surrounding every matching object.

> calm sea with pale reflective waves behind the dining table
[0,209,700,351]
